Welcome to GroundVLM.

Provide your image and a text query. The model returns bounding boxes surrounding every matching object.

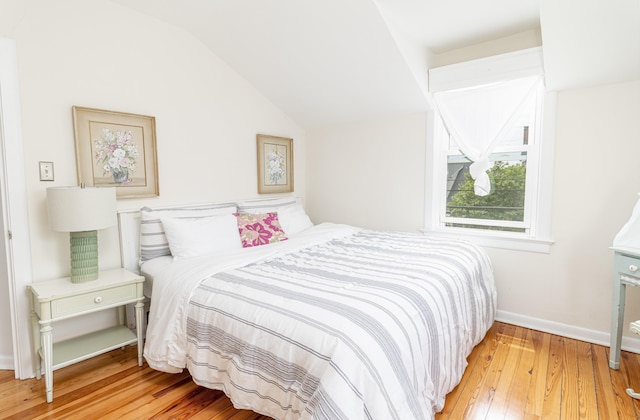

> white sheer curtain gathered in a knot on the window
[433,76,542,196]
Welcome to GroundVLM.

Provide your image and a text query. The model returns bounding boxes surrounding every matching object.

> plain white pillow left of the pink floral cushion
[162,214,242,258]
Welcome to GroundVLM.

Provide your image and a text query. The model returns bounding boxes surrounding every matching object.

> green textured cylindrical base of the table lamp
[70,230,98,283]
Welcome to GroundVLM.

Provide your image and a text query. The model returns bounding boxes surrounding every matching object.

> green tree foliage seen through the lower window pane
[447,161,526,221]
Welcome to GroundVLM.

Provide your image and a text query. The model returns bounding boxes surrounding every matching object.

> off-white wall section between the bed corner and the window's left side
[306,113,426,232]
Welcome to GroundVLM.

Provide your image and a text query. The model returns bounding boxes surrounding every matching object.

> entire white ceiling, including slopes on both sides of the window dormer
[111,0,640,128]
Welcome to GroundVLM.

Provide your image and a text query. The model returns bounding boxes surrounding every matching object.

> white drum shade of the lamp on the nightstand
[47,187,117,232]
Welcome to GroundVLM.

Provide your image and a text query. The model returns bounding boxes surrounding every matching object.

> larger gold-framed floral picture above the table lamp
[73,106,159,198]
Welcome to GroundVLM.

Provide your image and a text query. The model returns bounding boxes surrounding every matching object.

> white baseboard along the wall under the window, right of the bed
[496,309,640,353]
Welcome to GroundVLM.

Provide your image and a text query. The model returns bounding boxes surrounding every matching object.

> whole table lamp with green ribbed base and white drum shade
[47,186,116,283]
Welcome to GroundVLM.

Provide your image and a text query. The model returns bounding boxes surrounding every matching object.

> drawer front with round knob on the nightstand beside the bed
[51,284,137,319]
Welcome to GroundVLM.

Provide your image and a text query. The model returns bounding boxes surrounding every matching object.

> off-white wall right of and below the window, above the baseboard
[491,81,640,334]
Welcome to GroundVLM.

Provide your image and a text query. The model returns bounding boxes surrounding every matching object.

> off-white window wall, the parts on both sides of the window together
[307,82,640,344]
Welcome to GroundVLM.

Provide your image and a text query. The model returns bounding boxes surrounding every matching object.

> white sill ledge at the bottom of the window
[420,229,553,254]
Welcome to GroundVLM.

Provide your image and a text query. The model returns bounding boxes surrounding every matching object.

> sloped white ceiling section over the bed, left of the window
[114,0,436,128]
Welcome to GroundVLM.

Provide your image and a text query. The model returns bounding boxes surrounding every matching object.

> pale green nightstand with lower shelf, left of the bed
[28,268,144,402]
